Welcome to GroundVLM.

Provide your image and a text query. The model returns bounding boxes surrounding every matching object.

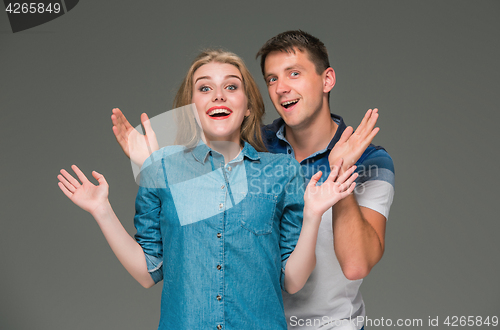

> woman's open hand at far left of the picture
[57,165,109,215]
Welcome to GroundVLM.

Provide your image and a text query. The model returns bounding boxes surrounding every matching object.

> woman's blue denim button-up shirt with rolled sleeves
[134,143,304,329]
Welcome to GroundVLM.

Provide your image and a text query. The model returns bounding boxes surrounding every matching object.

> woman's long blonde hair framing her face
[174,49,267,151]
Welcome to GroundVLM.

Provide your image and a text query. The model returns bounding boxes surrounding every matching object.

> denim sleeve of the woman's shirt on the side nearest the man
[280,158,305,291]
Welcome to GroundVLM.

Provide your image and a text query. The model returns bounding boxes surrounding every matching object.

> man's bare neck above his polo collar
[285,109,338,162]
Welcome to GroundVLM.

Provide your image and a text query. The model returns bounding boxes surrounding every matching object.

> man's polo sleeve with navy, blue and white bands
[354,146,395,219]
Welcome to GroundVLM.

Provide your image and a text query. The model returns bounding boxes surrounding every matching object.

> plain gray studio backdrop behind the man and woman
[0,0,500,330]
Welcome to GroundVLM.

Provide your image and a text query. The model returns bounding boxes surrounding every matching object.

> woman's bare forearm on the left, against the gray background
[92,201,155,288]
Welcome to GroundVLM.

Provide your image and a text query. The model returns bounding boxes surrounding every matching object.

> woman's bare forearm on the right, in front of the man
[285,209,321,294]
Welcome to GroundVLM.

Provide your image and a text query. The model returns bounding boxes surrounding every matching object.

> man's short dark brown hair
[255,30,330,75]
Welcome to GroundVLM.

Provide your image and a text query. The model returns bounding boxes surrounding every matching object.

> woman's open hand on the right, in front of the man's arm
[304,159,358,218]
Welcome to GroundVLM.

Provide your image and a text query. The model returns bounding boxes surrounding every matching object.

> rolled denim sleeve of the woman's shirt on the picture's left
[134,154,163,283]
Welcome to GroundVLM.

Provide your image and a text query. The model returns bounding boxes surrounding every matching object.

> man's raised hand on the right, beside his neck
[328,109,379,173]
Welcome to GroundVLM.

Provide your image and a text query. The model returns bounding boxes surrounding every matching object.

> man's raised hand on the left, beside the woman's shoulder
[111,108,159,167]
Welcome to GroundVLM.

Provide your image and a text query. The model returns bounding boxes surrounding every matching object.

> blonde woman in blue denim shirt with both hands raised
[58,50,356,329]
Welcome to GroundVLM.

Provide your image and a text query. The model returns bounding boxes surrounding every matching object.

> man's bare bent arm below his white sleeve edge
[332,195,385,280]
